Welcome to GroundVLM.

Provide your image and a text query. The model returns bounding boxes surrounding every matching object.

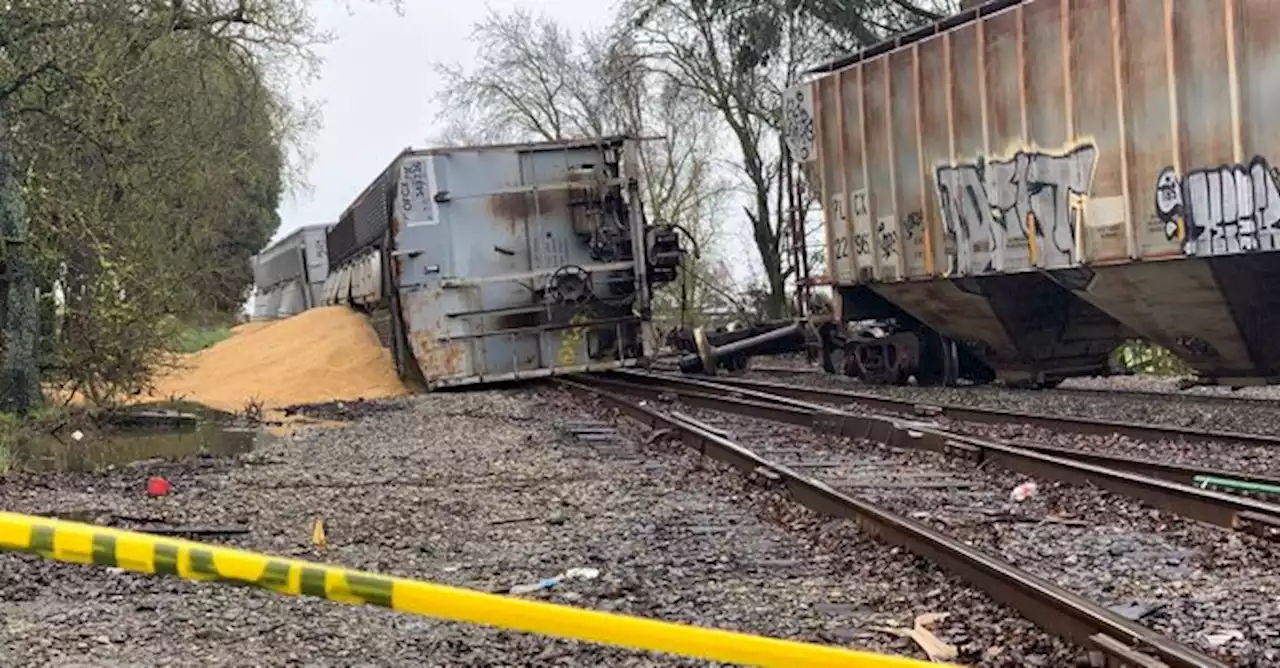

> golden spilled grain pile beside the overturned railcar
[154,306,407,412]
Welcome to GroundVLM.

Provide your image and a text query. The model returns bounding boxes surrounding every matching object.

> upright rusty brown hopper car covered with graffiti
[785,0,1280,385]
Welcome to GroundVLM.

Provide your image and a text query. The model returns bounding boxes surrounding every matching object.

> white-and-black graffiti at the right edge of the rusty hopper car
[1156,156,1280,256]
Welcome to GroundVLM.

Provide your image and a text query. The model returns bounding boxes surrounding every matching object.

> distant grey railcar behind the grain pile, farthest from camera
[250,225,329,320]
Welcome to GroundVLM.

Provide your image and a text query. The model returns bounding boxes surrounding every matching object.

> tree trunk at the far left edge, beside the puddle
[0,109,41,416]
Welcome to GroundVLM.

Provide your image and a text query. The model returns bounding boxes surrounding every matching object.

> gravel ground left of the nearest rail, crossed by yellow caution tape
[0,390,1079,667]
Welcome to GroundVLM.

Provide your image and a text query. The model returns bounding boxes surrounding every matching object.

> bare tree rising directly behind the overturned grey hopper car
[436,10,728,325]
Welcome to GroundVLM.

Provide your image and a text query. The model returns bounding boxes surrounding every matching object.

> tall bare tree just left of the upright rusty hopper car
[622,0,955,317]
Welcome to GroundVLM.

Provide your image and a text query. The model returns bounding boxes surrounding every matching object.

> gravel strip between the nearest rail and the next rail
[670,394,1280,665]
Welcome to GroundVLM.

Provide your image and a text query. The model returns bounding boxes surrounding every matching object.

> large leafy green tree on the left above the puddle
[0,0,396,413]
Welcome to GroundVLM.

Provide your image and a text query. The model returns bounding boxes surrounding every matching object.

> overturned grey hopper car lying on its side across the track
[324,137,681,389]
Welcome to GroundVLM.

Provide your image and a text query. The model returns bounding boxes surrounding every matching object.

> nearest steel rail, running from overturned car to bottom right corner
[556,376,1225,668]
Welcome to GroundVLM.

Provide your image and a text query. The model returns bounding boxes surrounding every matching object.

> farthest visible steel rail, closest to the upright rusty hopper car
[716,378,1280,447]
